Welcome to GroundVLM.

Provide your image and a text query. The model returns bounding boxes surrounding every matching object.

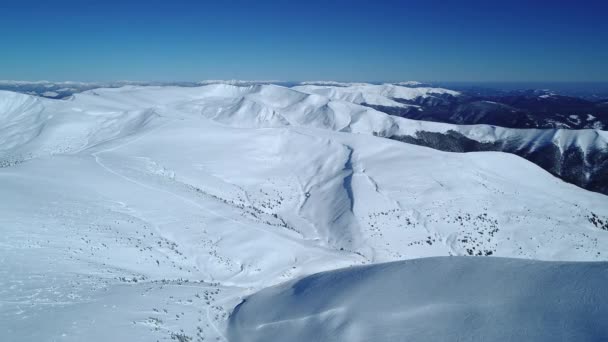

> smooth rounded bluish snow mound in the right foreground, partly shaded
[228,257,608,342]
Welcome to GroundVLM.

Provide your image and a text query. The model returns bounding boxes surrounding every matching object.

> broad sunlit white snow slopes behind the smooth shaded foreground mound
[0,84,608,341]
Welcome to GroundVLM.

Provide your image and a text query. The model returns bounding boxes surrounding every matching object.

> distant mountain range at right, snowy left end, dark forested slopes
[308,82,608,129]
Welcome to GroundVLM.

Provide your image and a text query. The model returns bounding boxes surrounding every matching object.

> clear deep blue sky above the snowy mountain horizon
[0,0,608,81]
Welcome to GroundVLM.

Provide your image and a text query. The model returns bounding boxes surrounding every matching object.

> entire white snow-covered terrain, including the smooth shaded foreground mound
[0,84,608,342]
